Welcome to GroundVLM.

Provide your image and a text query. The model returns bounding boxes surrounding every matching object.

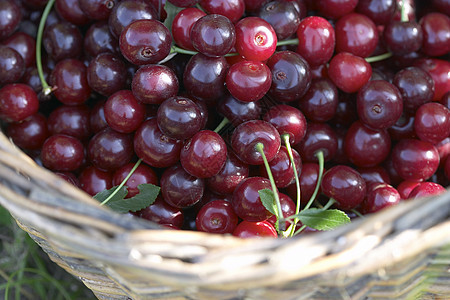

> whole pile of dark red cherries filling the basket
[0,0,450,237]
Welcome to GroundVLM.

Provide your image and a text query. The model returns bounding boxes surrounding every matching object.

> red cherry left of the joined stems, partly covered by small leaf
[232,177,272,222]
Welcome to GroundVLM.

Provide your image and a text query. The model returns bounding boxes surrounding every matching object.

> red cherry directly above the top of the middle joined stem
[263,104,307,145]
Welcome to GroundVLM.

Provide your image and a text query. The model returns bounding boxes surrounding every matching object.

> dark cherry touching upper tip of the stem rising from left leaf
[134,118,183,168]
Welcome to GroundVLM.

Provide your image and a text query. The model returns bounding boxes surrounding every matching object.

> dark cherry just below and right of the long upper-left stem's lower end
[47,105,91,141]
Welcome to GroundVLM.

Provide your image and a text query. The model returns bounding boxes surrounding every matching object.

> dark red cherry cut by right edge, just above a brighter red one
[419,12,450,56]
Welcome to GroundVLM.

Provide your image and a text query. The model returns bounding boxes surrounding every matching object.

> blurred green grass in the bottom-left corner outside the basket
[0,206,96,300]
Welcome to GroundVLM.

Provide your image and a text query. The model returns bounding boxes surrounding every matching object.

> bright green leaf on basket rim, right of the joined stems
[296,208,350,230]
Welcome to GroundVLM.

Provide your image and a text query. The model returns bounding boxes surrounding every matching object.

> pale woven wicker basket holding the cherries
[0,133,450,300]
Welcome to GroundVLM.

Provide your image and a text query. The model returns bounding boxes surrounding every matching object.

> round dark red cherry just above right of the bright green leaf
[321,165,366,210]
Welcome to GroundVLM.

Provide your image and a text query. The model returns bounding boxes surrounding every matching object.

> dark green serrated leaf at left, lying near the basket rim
[94,183,160,214]
